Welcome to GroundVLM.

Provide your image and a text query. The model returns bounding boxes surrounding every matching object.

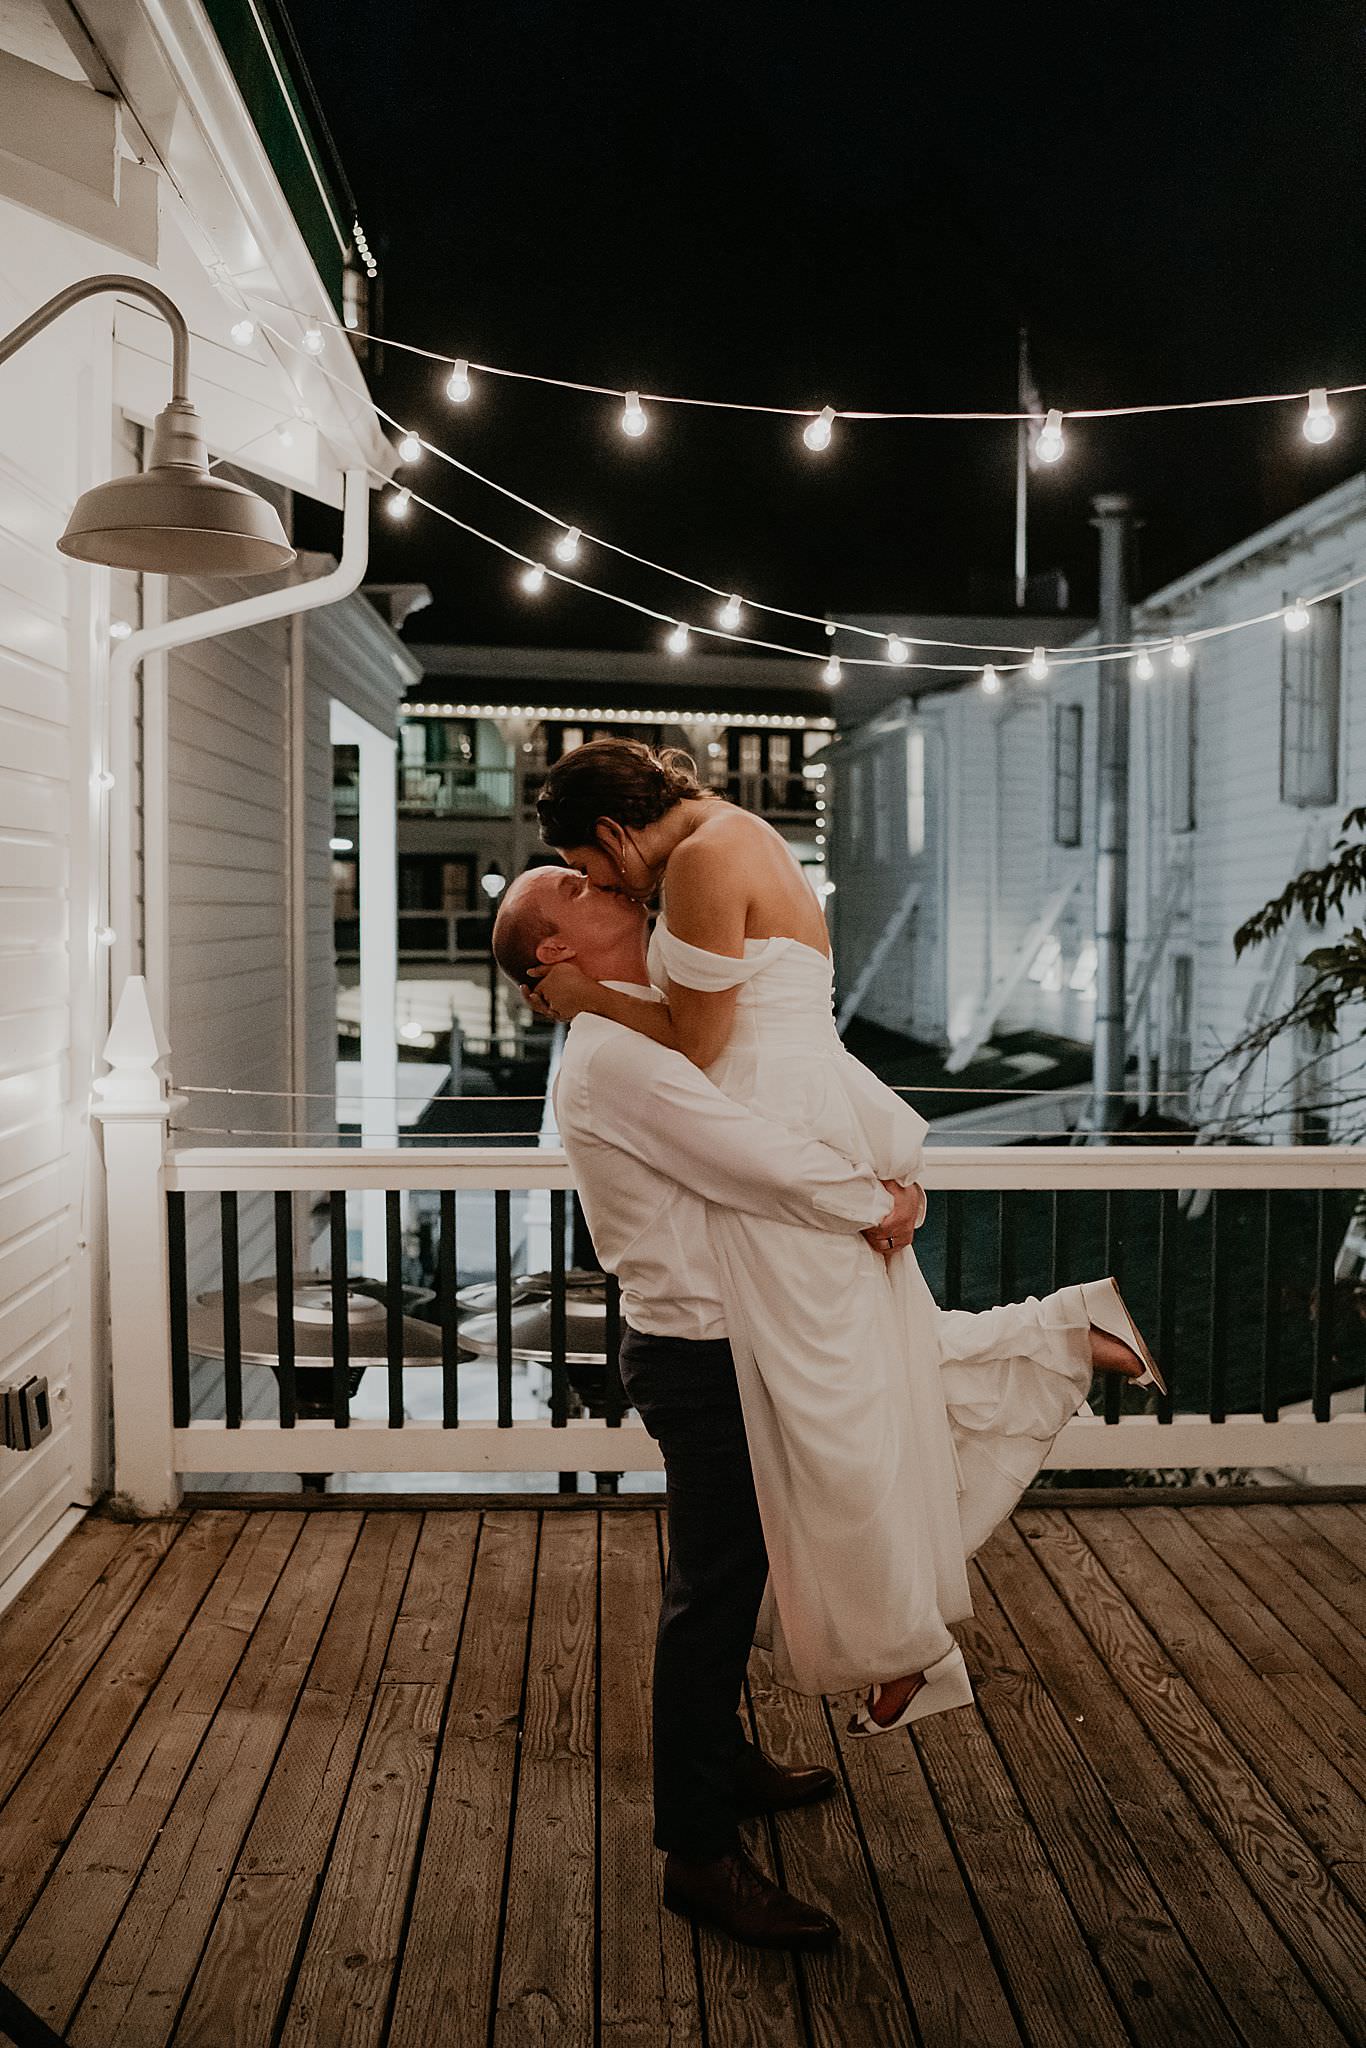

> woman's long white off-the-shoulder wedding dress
[649,918,1092,1694]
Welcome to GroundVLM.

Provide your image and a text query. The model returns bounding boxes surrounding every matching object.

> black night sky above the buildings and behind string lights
[289,0,1366,647]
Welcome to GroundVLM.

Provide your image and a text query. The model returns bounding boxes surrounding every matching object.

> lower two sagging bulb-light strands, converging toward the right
[248,322,1366,696]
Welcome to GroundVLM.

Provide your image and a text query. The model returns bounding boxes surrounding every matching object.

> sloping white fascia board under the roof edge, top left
[82,0,393,506]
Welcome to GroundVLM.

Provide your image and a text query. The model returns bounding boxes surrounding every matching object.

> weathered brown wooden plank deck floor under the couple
[0,1501,1366,2048]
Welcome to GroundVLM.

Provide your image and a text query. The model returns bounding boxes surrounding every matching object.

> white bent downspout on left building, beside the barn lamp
[109,469,371,1030]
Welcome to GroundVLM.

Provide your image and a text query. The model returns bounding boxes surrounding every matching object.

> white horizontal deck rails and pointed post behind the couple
[96,983,1366,1511]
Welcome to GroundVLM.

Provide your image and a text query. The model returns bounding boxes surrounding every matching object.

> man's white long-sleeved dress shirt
[555,981,891,1339]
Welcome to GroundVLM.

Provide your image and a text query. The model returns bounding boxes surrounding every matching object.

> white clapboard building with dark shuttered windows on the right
[829,477,1366,1139]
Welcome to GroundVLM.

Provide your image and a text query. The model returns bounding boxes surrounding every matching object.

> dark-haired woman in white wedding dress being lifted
[526,739,1165,1735]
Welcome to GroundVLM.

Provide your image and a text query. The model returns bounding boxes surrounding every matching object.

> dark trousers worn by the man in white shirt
[621,1327,768,1860]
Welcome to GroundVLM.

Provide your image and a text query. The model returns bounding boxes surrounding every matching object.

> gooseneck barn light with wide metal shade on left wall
[0,276,295,575]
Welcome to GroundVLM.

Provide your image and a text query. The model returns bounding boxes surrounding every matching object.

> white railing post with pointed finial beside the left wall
[92,975,180,1516]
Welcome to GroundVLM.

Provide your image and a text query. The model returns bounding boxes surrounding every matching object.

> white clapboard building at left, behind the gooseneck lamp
[0,0,405,1581]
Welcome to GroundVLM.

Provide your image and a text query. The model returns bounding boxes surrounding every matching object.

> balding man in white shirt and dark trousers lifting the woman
[494,866,920,1948]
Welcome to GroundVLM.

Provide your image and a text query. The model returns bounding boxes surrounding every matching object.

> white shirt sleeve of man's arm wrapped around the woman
[580,1026,891,1233]
